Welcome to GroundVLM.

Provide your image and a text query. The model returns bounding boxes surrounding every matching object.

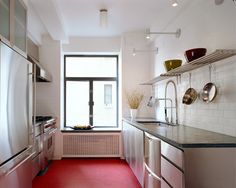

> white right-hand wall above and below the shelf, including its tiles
[153,0,236,136]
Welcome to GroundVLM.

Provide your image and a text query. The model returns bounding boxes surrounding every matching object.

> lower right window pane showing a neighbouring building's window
[93,81,117,126]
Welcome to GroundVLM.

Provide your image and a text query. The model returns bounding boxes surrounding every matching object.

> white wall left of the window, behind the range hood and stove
[36,36,61,158]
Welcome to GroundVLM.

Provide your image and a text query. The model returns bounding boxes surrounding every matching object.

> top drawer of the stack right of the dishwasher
[161,141,184,170]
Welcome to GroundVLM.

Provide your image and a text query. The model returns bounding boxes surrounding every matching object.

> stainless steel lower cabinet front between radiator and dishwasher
[123,121,144,187]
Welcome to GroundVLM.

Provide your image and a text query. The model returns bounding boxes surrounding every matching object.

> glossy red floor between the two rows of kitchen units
[33,159,141,188]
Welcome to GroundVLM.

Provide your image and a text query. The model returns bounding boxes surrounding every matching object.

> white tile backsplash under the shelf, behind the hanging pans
[155,58,236,136]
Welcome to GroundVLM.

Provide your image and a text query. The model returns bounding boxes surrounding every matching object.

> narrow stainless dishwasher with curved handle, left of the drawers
[144,132,161,188]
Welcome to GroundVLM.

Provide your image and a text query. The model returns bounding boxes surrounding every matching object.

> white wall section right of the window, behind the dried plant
[122,32,154,117]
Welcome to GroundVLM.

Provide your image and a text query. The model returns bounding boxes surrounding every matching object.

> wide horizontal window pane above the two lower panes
[66,56,117,77]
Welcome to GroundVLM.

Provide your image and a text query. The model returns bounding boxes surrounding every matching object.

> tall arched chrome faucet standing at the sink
[164,80,178,125]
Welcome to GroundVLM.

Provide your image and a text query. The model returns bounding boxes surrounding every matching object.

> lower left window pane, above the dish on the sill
[66,81,89,126]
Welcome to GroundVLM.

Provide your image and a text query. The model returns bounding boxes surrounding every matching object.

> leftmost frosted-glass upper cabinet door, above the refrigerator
[0,0,10,41]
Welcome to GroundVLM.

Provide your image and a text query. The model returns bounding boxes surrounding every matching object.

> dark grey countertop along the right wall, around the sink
[123,118,236,149]
